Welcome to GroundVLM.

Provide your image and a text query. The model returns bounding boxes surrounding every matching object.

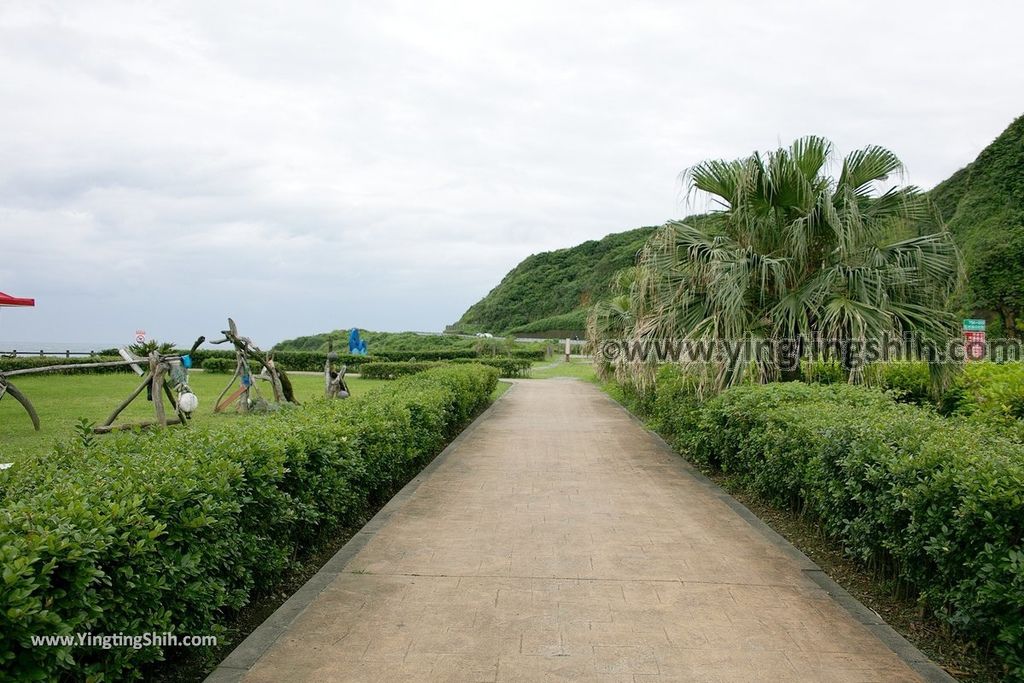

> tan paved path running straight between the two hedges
[211,380,951,683]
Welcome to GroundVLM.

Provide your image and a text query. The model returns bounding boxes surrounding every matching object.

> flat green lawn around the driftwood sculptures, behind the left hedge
[0,372,382,463]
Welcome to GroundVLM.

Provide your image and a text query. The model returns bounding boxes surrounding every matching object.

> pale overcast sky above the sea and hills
[0,0,1024,345]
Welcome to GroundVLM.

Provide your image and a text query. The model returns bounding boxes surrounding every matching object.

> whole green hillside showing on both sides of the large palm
[451,117,1024,336]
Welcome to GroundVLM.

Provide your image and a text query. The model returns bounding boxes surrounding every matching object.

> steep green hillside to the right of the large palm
[930,116,1024,335]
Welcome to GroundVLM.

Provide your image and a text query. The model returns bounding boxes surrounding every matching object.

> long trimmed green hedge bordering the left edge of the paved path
[0,366,498,681]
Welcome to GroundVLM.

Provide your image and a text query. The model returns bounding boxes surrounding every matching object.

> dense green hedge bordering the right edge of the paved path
[637,368,1024,680]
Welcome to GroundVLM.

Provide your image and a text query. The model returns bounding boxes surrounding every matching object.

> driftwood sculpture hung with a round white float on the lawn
[93,337,206,434]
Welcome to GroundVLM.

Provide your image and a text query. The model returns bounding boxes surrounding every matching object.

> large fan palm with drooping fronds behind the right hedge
[598,136,963,390]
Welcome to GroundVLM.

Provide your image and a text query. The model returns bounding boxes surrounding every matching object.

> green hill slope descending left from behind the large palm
[450,227,654,336]
